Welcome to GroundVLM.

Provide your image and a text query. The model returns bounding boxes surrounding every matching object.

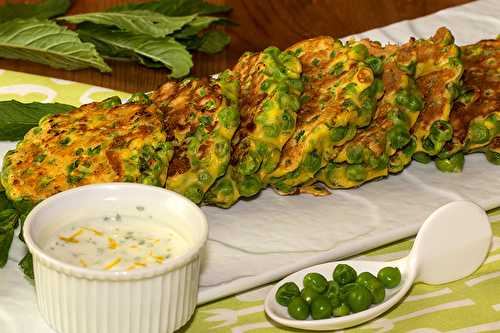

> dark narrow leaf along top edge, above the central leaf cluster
[109,0,231,16]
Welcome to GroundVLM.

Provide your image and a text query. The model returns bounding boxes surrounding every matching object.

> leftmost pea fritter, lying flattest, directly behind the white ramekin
[1,97,173,204]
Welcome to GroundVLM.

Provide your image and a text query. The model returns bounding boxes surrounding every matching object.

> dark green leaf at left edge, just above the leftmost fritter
[0,100,74,140]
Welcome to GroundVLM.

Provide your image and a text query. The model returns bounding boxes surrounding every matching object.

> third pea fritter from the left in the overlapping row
[205,47,303,208]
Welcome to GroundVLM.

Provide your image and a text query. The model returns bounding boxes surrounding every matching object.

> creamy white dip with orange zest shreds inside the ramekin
[44,214,190,271]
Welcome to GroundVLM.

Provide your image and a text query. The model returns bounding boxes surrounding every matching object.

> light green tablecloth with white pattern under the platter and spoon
[0,70,500,333]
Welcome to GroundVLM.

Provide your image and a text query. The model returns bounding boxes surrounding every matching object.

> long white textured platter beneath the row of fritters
[0,0,500,333]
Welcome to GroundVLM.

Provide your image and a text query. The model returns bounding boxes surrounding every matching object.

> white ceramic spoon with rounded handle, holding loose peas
[265,201,492,331]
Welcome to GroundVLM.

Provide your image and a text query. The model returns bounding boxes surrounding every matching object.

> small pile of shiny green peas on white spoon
[275,264,401,320]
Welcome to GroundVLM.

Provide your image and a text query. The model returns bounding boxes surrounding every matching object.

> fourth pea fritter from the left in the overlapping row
[269,36,383,195]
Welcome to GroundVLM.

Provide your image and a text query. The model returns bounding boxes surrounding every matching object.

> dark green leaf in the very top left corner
[0,0,71,22]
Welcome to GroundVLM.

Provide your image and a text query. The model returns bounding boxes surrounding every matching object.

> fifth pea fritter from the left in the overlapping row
[316,40,423,188]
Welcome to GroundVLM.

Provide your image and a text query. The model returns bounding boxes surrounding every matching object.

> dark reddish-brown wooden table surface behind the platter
[0,0,470,92]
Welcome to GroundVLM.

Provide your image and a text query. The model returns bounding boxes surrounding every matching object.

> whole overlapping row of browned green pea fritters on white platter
[1,28,500,207]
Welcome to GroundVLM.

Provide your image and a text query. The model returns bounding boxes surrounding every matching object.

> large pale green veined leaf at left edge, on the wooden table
[0,19,111,72]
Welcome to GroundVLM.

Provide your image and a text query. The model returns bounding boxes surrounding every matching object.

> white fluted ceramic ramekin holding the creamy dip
[24,183,208,333]
